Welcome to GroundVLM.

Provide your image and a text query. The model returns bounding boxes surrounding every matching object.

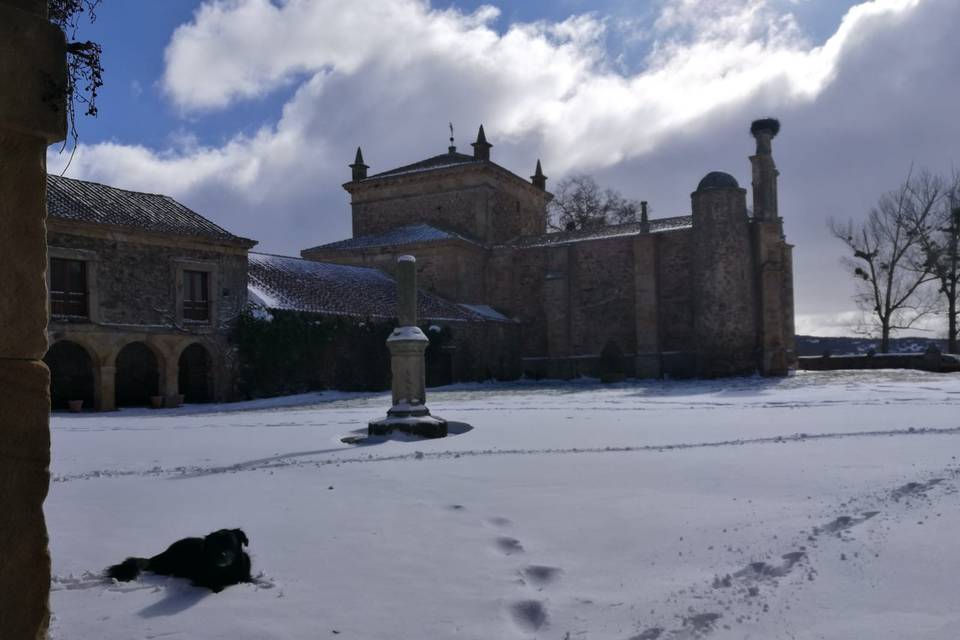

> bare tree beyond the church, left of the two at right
[830,171,943,353]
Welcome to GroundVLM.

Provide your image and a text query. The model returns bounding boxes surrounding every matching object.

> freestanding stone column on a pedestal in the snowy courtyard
[369,256,447,438]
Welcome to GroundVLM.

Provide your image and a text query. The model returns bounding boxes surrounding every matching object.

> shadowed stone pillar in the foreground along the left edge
[0,0,66,639]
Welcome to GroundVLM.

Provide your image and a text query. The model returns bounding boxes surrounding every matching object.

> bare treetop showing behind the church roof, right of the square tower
[547,173,640,230]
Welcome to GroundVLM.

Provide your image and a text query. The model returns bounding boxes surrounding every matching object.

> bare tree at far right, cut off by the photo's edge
[916,170,960,353]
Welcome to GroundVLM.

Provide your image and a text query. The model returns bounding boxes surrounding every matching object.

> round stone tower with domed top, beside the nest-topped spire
[691,171,757,377]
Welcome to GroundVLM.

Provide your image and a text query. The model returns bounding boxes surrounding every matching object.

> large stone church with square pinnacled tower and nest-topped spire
[301,119,795,377]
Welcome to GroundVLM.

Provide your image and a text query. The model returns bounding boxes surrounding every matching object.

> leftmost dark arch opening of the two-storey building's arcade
[43,340,100,410]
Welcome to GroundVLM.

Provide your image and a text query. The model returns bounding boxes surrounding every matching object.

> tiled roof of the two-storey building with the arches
[47,174,253,246]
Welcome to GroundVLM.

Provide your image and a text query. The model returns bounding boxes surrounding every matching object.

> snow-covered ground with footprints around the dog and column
[46,371,960,640]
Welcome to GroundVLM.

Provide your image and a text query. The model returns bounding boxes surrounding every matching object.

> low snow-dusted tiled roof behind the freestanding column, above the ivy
[247,252,506,322]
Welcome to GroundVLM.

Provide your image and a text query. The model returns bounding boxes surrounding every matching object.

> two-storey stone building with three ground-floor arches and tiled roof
[45,176,256,410]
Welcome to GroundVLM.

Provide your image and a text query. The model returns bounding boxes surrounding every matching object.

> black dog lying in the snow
[106,529,252,593]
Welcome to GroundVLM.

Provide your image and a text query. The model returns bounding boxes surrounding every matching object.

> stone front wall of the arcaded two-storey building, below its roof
[46,178,254,410]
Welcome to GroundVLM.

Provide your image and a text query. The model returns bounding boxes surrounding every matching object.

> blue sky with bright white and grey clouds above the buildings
[49,0,960,334]
